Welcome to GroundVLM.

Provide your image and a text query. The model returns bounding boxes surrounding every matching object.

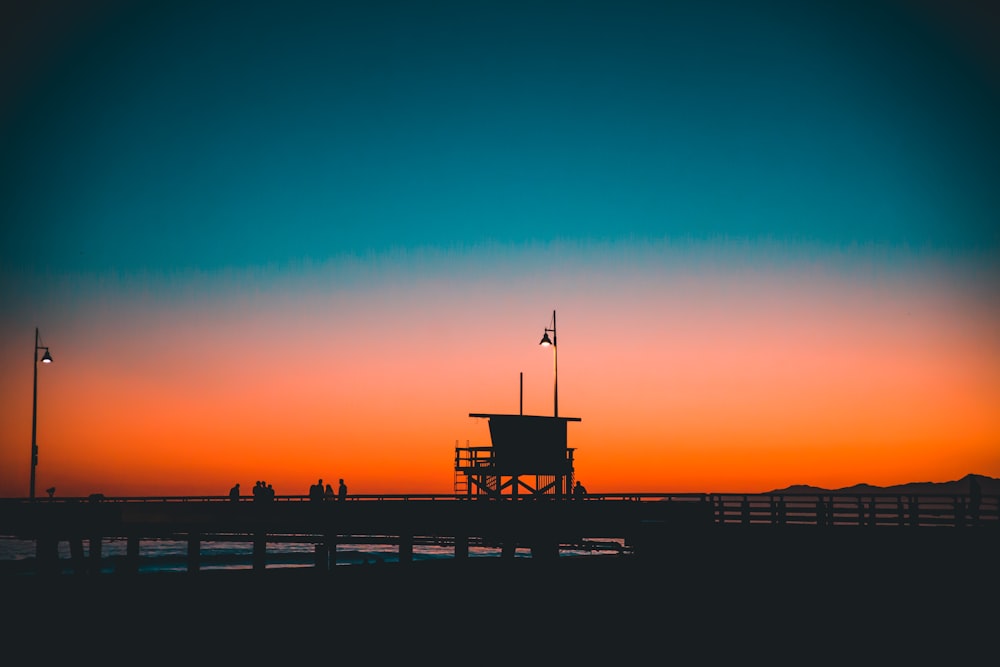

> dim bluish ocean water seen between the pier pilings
[0,536,625,573]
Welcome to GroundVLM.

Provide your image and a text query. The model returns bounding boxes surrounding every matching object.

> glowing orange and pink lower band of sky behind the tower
[0,243,1000,496]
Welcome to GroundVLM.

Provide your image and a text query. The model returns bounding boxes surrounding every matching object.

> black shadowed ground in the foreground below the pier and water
[0,533,1000,665]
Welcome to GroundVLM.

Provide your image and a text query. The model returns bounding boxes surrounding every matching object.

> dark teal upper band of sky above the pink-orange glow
[0,1,1000,275]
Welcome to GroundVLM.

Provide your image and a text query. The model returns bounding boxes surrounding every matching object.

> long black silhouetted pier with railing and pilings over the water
[0,493,1000,574]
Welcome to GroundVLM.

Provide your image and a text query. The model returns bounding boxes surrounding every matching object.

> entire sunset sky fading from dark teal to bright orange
[0,0,1000,497]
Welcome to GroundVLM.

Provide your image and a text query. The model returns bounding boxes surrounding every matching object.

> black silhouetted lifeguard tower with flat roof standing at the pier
[455,412,580,498]
